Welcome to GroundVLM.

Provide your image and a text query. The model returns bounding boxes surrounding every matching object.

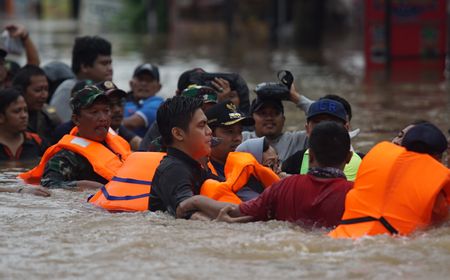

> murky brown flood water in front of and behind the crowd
[0,18,450,279]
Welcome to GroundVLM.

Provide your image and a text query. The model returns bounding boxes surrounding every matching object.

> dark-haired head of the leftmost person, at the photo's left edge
[0,88,28,134]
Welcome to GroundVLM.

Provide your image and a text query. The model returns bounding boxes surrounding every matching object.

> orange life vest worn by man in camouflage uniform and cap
[19,127,131,184]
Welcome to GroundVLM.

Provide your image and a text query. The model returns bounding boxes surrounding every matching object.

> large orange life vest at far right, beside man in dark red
[328,142,450,238]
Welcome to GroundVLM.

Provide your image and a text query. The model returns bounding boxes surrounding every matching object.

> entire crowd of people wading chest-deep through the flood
[0,25,450,238]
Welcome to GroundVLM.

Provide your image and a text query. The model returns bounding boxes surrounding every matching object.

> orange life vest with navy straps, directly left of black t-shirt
[88,152,165,211]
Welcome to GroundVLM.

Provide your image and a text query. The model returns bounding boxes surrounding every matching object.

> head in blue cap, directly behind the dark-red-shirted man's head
[305,99,348,135]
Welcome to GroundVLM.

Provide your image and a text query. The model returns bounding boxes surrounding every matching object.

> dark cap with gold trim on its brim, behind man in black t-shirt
[205,100,255,127]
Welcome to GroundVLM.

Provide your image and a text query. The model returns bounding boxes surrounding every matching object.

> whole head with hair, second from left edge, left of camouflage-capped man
[13,64,48,112]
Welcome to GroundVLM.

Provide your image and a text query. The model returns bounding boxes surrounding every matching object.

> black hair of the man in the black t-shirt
[156,96,203,146]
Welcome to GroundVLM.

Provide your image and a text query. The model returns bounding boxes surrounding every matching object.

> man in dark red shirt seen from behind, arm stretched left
[177,121,353,227]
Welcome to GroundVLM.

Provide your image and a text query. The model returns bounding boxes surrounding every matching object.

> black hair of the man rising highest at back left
[72,36,111,74]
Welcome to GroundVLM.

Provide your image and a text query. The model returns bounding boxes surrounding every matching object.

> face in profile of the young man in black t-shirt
[183,109,212,160]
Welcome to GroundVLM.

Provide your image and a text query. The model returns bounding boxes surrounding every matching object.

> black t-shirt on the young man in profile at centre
[149,148,208,216]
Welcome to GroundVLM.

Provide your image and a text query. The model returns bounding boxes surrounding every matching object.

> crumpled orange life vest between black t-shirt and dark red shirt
[200,152,280,204]
